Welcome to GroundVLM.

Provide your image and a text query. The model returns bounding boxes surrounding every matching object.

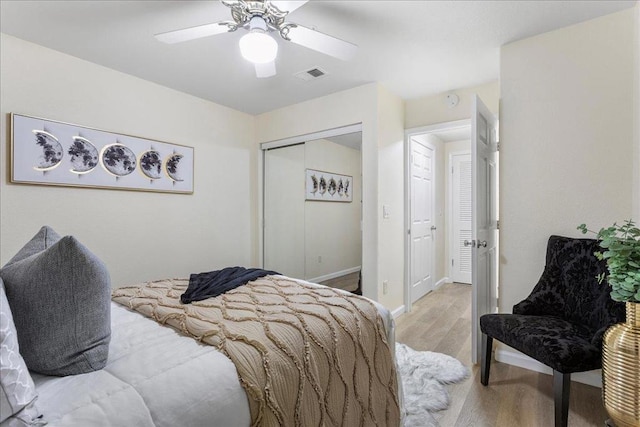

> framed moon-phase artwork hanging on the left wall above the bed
[11,114,194,194]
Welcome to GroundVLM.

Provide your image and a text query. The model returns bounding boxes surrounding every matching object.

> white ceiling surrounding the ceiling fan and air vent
[0,0,636,114]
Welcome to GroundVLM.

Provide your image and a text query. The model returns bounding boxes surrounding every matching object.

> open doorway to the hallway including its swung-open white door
[405,96,498,363]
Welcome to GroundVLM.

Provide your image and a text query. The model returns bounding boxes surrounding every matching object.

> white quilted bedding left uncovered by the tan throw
[32,282,402,427]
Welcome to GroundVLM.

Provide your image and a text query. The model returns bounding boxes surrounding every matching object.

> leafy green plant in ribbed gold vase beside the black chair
[578,220,640,427]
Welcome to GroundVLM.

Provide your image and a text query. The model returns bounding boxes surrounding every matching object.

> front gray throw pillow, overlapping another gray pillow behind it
[0,236,111,376]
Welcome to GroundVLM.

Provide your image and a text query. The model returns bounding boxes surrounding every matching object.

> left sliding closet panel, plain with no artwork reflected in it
[264,144,305,277]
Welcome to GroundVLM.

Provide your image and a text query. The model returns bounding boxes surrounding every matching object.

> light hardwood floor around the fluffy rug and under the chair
[396,283,608,427]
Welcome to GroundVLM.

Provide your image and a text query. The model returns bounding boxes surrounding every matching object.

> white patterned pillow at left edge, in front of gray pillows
[0,278,39,425]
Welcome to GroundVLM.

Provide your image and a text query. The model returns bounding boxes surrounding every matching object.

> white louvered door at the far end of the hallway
[451,153,473,284]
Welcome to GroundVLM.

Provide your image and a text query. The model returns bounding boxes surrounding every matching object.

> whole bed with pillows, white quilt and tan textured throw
[0,226,402,427]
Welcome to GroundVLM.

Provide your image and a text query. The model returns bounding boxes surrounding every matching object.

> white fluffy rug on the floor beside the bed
[396,343,469,427]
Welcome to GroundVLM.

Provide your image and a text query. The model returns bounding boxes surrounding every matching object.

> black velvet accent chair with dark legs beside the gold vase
[480,236,625,427]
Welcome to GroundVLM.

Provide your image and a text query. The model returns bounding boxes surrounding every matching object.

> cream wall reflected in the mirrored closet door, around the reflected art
[302,139,362,280]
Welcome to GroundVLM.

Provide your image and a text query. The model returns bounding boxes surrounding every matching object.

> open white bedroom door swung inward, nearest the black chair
[470,96,498,363]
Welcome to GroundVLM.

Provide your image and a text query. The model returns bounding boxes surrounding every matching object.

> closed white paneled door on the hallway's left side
[409,138,435,303]
